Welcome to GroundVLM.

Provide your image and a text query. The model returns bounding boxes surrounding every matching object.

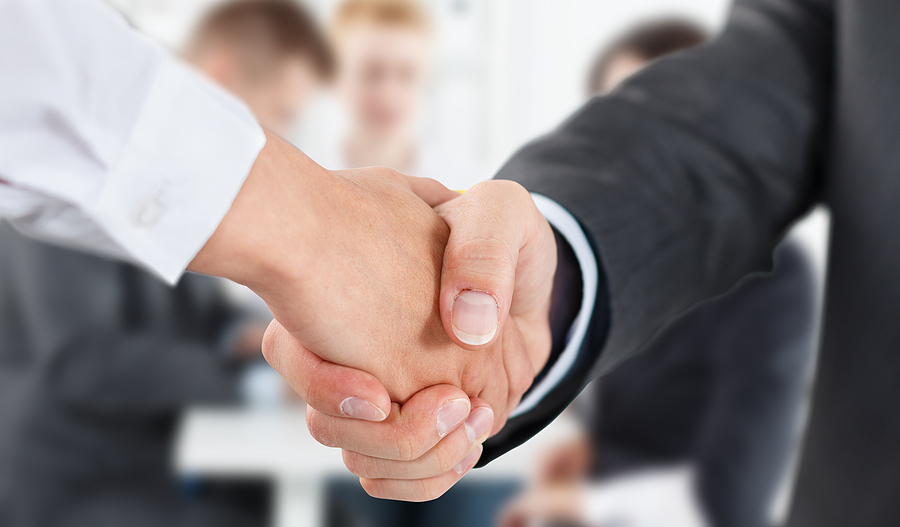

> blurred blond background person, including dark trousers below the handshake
[313,0,500,527]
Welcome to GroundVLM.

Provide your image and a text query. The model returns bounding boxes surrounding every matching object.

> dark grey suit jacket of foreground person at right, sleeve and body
[488,0,900,527]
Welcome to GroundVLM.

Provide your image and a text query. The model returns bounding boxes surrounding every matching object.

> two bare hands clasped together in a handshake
[190,130,556,501]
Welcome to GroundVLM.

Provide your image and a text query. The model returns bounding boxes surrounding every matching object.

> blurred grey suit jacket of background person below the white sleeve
[0,224,261,527]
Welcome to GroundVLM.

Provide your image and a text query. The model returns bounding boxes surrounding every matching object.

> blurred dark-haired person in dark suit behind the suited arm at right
[502,20,816,527]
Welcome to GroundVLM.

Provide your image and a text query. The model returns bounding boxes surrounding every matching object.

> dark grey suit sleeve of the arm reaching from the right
[489,0,834,457]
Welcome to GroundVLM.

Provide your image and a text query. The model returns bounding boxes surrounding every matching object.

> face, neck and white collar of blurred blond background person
[313,0,488,189]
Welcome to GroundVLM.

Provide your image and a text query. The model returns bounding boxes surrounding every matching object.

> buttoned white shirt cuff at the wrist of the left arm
[85,60,266,282]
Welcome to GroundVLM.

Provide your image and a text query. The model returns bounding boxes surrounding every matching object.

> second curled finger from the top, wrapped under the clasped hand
[306,384,471,461]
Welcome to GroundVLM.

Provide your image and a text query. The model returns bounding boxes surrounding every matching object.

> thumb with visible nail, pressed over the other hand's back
[436,181,534,350]
